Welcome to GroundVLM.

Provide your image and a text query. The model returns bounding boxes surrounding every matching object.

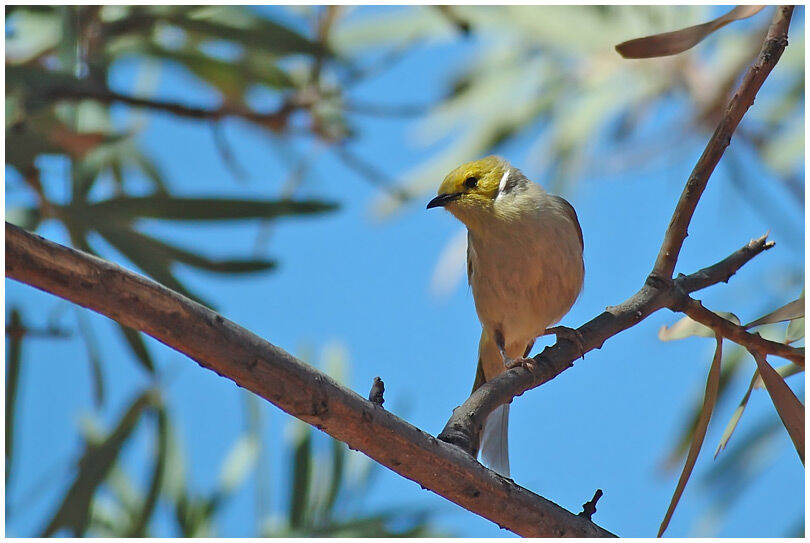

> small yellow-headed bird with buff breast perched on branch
[427,156,585,477]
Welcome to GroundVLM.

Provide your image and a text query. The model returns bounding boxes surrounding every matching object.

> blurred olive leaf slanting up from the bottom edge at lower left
[42,389,160,537]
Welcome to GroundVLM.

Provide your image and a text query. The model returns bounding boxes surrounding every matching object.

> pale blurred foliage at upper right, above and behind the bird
[333,6,804,215]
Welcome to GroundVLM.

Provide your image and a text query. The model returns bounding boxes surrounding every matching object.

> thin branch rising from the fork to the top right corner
[653,6,793,279]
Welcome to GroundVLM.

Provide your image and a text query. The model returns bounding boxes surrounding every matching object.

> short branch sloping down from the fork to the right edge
[672,294,804,367]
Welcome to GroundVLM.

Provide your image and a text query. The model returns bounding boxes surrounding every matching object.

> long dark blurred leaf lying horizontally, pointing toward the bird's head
[87,196,337,221]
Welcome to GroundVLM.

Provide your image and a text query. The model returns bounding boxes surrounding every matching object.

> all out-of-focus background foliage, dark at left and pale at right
[5,5,804,537]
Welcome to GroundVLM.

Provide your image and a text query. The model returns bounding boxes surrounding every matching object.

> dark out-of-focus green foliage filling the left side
[6,6,442,537]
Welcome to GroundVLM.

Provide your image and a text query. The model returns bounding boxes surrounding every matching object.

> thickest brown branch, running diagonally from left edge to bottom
[6,223,612,537]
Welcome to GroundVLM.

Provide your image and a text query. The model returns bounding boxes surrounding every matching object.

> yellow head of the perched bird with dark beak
[427,156,514,225]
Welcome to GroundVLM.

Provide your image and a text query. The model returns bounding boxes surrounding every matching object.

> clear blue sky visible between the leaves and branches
[6,5,804,537]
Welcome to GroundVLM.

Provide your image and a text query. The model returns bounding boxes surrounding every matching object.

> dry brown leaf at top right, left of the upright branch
[616,6,765,58]
